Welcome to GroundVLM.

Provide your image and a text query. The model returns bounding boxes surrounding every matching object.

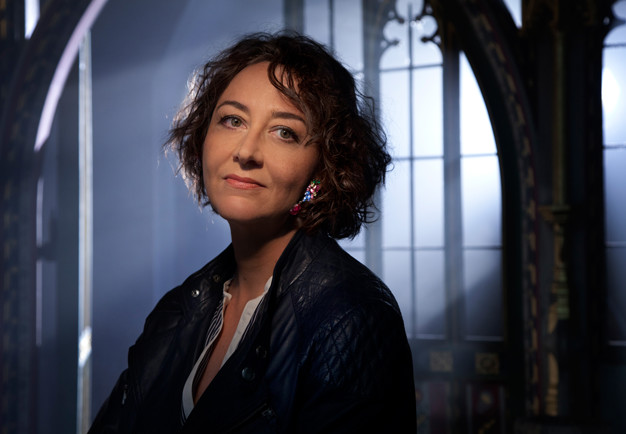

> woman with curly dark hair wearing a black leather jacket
[90,33,416,433]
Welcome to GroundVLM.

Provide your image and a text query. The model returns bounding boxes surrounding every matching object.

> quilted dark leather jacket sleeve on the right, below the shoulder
[295,300,417,433]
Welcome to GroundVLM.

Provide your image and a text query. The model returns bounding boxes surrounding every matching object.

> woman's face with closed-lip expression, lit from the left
[202,62,318,229]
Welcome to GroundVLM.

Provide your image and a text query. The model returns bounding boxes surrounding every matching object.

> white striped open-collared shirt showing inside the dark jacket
[182,276,272,423]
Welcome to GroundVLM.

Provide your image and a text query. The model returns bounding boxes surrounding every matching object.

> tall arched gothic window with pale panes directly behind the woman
[304,0,520,432]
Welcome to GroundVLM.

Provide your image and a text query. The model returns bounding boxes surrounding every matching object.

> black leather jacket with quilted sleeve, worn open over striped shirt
[89,232,416,434]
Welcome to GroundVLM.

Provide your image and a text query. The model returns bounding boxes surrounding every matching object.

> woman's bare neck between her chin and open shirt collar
[230,224,296,298]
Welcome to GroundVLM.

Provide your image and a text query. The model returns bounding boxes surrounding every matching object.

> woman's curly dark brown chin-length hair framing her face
[166,31,391,239]
